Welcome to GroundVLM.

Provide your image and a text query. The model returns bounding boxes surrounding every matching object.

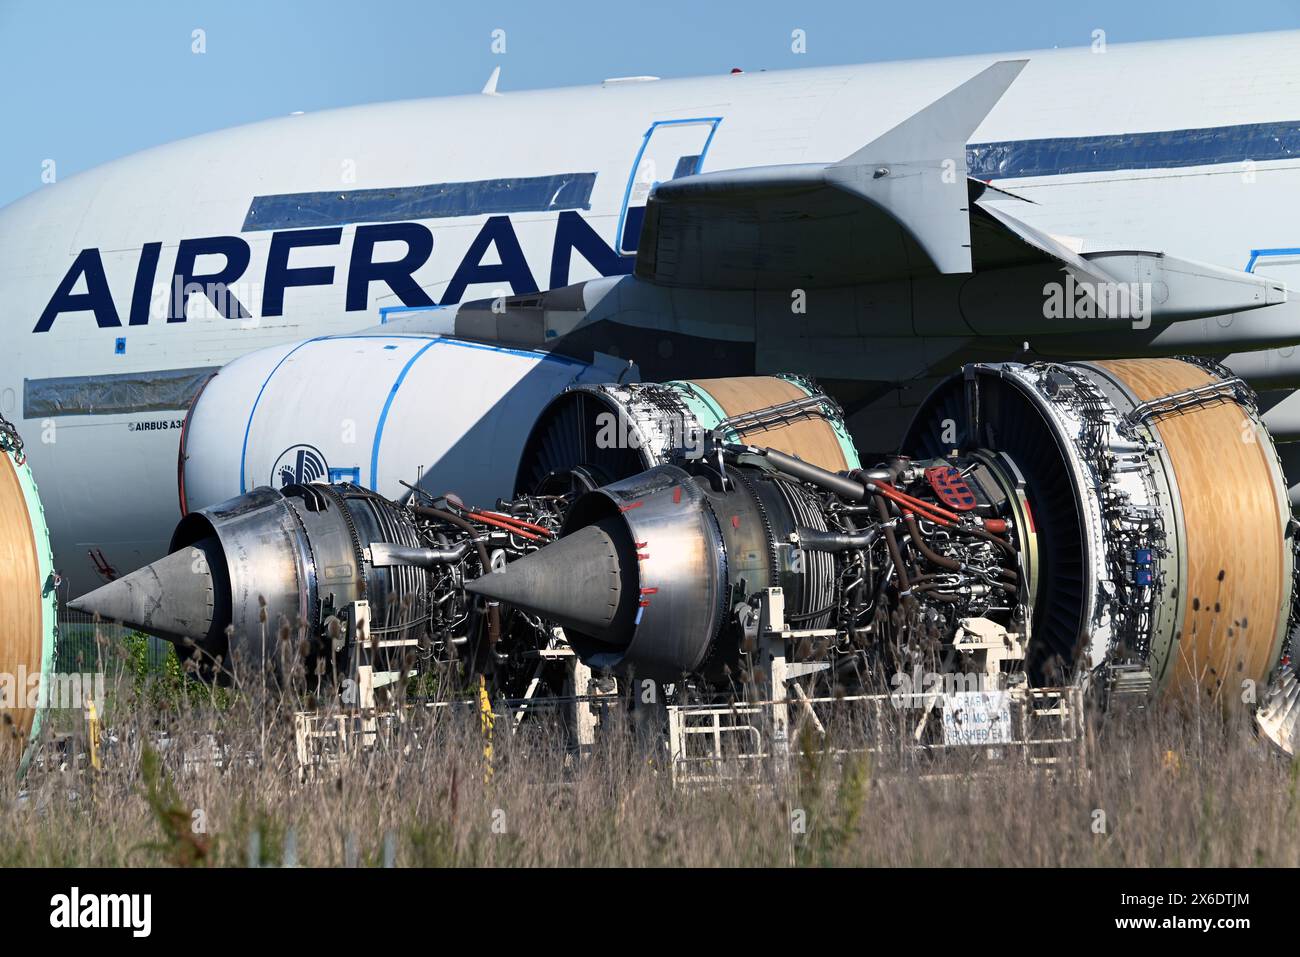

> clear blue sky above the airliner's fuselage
[0,0,1300,205]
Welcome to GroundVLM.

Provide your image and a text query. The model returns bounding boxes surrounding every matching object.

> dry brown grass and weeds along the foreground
[10,650,1300,866]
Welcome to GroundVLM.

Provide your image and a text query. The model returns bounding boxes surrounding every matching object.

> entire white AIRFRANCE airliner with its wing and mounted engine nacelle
[0,33,1300,594]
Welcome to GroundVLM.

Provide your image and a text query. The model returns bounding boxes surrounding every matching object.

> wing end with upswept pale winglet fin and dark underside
[634,60,1026,289]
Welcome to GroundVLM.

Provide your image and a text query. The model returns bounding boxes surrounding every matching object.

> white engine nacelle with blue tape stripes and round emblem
[179,334,634,511]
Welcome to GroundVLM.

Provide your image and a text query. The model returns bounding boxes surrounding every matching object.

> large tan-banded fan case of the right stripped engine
[906,359,1295,702]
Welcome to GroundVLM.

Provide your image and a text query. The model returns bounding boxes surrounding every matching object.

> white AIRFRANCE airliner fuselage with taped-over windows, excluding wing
[0,33,1300,594]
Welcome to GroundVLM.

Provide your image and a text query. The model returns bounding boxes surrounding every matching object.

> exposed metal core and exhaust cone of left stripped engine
[70,484,569,679]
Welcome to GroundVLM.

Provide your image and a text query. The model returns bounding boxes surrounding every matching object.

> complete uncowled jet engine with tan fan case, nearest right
[468,359,1295,702]
